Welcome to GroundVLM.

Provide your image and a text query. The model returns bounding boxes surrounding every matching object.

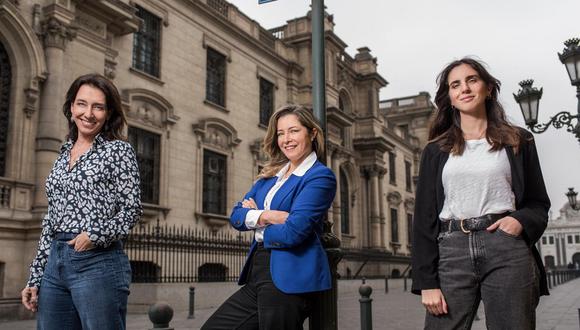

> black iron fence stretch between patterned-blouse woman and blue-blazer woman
[125,221,252,283]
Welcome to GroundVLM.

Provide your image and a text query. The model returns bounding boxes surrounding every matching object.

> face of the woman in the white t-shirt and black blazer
[447,63,491,114]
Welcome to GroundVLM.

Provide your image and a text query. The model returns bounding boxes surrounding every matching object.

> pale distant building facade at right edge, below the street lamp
[537,203,580,269]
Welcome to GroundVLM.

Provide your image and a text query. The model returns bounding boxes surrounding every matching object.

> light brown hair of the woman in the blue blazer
[258,104,324,179]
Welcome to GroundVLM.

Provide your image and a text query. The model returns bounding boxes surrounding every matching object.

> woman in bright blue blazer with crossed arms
[202,105,336,330]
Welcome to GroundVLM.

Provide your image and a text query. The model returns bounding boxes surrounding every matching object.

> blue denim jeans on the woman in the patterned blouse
[37,234,131,330]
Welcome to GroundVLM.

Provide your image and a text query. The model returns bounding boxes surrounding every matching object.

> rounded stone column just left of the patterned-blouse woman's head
[33,14,76,218]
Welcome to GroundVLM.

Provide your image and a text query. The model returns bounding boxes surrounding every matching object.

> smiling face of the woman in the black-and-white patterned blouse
[71,85,107,141]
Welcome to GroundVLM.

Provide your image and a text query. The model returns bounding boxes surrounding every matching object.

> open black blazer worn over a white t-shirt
[412,129,550,295]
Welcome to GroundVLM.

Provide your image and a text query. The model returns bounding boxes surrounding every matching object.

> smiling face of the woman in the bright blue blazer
[276,114,316,166]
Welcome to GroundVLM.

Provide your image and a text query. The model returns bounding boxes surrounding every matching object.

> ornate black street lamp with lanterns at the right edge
[514,38,580,142]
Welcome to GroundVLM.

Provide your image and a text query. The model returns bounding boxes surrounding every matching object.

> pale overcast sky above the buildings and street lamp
[230,0,580,216]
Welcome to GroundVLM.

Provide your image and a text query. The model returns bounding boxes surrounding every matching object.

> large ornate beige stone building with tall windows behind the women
[0,0,433,297]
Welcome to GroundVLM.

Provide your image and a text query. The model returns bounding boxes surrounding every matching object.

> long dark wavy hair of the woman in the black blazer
[429,57,522,155]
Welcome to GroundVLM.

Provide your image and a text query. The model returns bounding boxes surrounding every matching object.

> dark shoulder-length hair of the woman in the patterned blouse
[62,73,127,141]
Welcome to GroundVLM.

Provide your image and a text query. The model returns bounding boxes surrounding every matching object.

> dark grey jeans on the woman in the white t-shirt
[425,229,540,330]
